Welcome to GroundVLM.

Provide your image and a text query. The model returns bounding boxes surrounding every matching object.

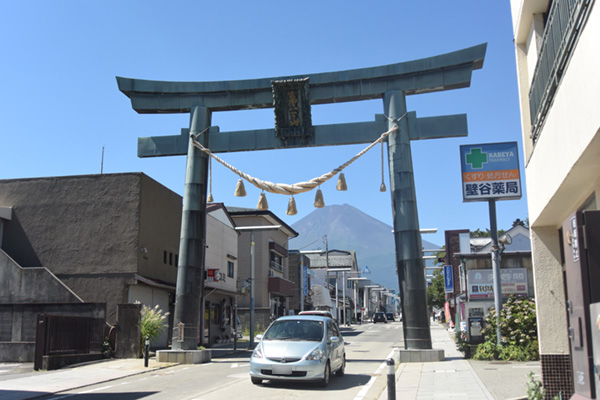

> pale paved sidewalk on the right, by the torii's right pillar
[379,323,540,400]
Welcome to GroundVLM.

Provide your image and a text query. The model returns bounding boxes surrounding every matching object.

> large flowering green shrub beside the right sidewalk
[473,296,539,361]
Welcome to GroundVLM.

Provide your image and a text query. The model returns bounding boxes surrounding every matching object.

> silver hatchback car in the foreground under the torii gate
[250,315,346,387]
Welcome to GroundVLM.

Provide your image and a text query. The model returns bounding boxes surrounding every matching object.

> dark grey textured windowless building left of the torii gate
[0,173,181,347]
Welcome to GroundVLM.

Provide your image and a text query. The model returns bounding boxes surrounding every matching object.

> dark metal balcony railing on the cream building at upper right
[529,0,595,143]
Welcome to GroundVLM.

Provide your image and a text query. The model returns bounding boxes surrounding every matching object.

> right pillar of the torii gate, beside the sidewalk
[383,90,432,349]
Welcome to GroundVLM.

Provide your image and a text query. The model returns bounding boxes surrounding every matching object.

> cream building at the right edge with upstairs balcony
[511,0,600,398]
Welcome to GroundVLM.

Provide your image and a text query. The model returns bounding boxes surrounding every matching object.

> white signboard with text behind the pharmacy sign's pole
[467,268,528,299]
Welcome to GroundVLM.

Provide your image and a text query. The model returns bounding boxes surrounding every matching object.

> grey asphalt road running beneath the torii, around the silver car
[34,322,402,400]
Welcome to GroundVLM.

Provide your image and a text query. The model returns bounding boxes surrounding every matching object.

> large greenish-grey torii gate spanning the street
[117,43,487,350]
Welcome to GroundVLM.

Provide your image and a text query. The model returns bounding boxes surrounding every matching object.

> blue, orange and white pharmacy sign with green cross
[460,142,521,201]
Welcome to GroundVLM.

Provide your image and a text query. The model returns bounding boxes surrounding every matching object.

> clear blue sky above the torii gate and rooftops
[0,0,527,245]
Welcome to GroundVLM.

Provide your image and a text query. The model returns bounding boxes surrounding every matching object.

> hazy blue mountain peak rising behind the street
[289,204,439,290]
